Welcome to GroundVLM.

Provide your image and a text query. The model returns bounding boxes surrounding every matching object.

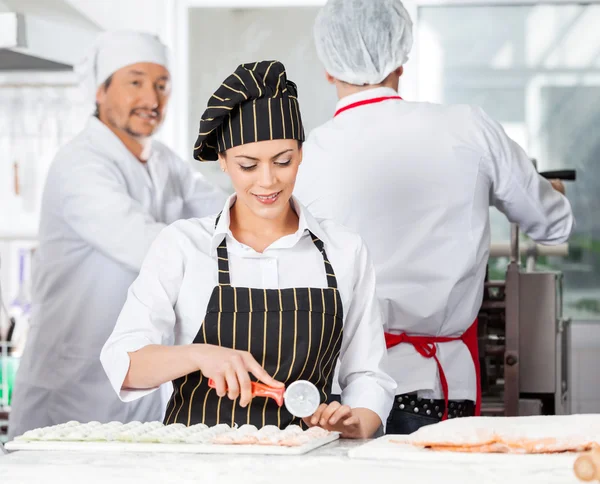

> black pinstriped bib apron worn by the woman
[165,228,343,428]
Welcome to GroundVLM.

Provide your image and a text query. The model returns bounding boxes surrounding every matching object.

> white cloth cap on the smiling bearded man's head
[80,30,169,95]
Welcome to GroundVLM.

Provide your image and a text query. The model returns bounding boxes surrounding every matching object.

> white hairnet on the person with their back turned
[314,0,413,85]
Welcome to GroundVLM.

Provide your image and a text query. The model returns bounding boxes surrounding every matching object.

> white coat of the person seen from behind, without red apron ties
[294,88,573,400]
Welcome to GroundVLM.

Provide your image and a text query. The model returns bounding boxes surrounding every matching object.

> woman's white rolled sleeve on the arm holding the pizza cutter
[100,221,185,402]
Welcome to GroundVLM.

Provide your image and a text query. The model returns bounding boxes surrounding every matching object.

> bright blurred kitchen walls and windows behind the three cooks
[0,0,600,419]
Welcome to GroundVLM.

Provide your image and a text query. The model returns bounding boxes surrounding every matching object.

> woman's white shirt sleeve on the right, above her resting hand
[339,239,396,426]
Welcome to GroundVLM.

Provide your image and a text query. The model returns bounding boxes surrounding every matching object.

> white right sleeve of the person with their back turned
[474,108,575,245]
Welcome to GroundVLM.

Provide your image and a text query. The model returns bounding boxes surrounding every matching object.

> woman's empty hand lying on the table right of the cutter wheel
[304,402,381,439]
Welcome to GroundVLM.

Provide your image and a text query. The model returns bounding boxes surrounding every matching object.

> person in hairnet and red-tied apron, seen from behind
[295,0,574,434]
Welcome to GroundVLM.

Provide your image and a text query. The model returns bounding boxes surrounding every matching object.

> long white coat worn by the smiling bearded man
[9,117,226,436]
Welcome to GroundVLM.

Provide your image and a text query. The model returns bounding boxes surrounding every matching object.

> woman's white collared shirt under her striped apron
[100,195,396,424]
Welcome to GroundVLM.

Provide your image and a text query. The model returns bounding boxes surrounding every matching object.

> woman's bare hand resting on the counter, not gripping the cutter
[303,402,371,439]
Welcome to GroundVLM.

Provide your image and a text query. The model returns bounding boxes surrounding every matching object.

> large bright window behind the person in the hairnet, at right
[418,3,600,319]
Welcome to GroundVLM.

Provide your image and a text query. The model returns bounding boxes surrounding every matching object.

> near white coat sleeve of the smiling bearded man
[60,155,165,272]
